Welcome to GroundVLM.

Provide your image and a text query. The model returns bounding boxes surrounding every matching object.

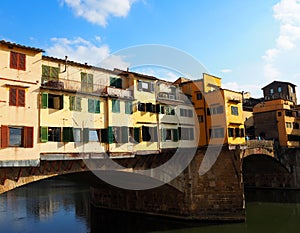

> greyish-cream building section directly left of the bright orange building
[156,80,198,150]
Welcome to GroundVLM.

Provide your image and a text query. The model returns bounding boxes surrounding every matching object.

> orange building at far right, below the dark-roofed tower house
[253,99,300,147]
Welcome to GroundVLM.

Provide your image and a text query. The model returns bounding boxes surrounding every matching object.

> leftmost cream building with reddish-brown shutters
[0,40,43,166]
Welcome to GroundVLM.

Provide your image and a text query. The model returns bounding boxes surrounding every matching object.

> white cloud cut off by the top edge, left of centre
[63,0,137,27]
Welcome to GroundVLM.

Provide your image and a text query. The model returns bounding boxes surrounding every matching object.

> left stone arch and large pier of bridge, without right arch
[0,146,245,221]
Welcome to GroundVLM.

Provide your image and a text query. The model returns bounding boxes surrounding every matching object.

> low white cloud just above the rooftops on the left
[46,37,129,69]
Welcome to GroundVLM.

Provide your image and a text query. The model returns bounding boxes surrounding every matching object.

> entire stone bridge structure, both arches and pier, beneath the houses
[0,144,300,221]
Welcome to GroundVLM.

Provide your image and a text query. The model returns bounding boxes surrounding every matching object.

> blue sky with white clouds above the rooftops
[0,0,300,97]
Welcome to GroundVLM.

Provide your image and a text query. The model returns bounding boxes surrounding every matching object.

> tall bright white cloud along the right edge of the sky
[262,0,300,94]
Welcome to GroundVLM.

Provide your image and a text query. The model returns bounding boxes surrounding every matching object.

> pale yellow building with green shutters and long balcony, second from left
[39,56,107,159]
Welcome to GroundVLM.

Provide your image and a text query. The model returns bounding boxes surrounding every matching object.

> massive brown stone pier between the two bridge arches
[91,146,245,221]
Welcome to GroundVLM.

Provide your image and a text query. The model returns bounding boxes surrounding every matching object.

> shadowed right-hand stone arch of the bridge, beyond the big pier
[241,140,300,189]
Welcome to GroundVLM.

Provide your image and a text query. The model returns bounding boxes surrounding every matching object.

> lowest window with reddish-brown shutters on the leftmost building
[1,125,34,148]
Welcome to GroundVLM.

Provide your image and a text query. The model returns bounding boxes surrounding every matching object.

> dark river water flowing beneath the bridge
[0,177,300,233]
